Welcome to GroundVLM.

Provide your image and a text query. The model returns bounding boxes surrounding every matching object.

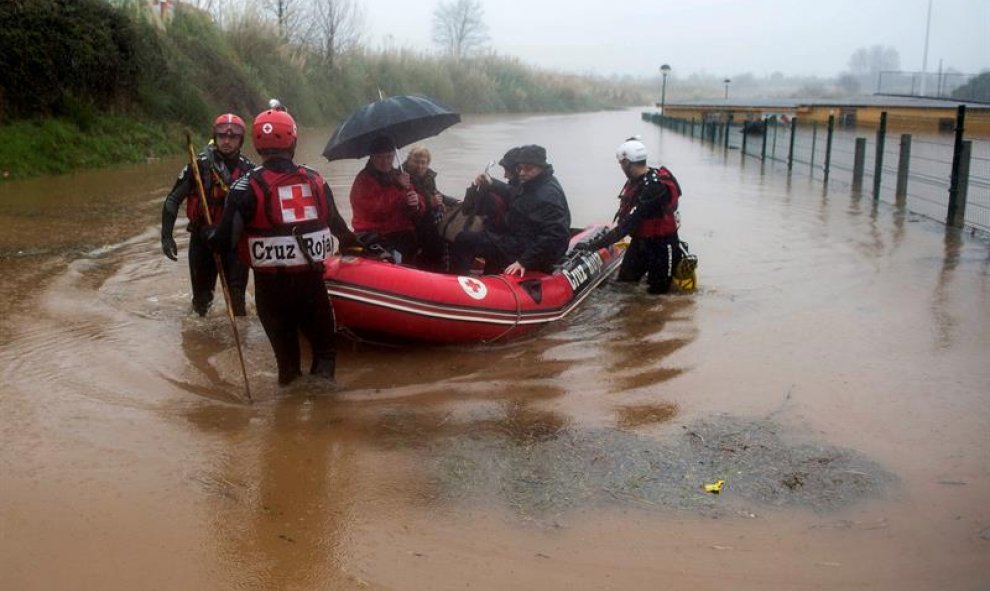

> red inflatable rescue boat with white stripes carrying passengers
[324,225,623,344]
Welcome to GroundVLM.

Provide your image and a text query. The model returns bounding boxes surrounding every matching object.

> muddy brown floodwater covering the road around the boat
[0,111,990,591]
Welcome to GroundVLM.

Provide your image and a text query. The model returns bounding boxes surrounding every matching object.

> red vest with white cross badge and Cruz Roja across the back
[240,166,333,273]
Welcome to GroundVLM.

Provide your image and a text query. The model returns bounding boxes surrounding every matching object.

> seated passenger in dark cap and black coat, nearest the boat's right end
[452,145,571,277]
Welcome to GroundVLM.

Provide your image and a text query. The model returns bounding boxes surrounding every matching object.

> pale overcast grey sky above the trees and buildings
[359,0,990,77]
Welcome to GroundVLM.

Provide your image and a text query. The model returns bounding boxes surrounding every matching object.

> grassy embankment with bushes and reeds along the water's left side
[0,0,648,179]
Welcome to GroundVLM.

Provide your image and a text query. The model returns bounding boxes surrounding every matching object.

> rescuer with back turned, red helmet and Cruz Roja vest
[208,108,357,386]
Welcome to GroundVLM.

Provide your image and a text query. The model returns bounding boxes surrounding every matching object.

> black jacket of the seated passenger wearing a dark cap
[496,168,571,271]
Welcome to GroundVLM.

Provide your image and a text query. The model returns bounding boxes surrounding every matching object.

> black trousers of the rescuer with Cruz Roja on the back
[254,271,336,385]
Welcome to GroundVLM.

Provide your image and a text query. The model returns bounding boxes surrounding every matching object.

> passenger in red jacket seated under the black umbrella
[351,137,426,263]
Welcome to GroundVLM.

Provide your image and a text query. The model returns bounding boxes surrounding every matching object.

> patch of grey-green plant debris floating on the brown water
[429,415,896,516]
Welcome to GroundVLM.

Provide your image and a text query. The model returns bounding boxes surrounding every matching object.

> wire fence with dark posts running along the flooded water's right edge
[643,113,990,232]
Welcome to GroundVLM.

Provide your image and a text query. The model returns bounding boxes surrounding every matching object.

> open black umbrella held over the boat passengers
[323,96,461,160]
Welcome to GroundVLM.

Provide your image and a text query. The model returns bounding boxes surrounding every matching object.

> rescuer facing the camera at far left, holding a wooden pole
[162,113,254,316]
